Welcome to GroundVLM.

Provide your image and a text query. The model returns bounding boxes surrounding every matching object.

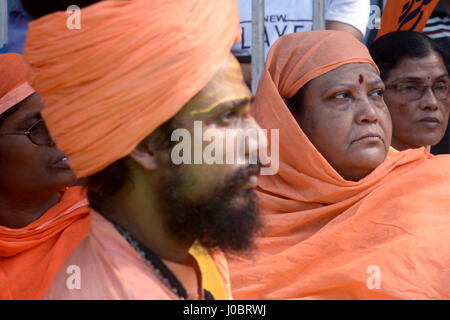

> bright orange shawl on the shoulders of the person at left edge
[0,187,90,300]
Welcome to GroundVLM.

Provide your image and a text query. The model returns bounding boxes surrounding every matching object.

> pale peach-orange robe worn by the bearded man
[45,210,230,300]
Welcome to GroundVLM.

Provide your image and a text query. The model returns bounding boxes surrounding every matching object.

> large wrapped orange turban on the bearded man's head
[24,0,240,177]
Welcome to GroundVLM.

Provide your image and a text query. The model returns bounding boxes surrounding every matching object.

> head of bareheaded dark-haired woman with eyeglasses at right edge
[369,31,450,151]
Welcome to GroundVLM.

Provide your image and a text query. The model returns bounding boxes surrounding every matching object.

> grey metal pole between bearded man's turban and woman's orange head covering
[252,0,265,94]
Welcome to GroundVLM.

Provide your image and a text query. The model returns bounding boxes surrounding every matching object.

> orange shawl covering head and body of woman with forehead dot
[229,31,450,299]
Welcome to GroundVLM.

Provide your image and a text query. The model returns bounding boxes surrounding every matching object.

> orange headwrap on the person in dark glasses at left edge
[0,53,34,114]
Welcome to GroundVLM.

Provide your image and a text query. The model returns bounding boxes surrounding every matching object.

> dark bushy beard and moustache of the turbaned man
[161,165,261,252]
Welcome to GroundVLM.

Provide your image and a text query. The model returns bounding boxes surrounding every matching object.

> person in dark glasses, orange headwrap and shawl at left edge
[0,53,89,299]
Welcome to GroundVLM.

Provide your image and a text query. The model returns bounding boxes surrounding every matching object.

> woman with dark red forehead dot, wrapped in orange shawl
[230,31,450,299]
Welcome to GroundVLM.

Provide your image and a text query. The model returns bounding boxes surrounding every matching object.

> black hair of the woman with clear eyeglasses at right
[369,31,449,81]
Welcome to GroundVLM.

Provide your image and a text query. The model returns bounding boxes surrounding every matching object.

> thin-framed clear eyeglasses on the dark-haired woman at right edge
[386,82,448,100]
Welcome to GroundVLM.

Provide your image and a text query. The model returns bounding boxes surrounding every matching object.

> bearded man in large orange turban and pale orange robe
[25,0,259,299]
